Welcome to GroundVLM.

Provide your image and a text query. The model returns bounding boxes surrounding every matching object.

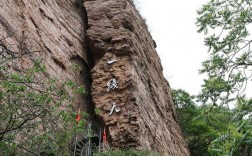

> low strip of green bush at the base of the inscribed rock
[94,150,160,156]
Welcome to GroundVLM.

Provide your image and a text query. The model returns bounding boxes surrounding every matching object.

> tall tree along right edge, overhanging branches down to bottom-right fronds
[196,0,252,156]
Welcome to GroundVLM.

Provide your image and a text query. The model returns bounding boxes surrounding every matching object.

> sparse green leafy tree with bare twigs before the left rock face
[0,36,85,155]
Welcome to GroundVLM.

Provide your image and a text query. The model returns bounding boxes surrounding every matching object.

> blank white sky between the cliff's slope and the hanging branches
[135,0,208,95]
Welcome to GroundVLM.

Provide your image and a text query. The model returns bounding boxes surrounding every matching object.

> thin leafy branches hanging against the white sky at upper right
[197,0,252,105]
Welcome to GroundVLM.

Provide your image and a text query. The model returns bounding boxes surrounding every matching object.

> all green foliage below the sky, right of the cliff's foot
[173,89,252,156]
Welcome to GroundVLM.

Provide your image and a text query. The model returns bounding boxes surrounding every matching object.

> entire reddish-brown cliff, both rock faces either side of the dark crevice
[0,0,189,156]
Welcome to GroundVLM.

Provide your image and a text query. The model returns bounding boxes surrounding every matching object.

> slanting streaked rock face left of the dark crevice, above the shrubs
[0,0,91,109]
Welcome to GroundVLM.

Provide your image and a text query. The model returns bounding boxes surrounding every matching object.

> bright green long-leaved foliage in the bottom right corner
[209,97,252,156]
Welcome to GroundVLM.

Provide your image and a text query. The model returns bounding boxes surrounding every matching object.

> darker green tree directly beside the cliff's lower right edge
[172,89,220,156]
